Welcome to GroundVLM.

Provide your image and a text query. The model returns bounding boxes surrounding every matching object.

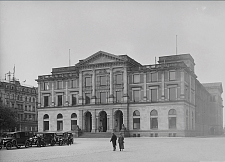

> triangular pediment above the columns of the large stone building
[79,51,125,65]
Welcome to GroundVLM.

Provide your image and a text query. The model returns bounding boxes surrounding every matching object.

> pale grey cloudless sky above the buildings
[0,1,225,123]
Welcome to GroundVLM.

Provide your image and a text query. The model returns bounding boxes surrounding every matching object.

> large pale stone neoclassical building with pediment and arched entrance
[36,51,223,136]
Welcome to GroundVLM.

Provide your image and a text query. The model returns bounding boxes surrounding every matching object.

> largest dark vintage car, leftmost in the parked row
[1,131,33,150]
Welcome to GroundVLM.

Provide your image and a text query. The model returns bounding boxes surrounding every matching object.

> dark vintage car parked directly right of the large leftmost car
[36,132,57,147]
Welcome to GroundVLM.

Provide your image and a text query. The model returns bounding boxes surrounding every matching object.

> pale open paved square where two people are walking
[0,137,225,162]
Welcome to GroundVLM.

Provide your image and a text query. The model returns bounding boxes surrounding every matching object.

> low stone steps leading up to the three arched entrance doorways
[79,132,119,138]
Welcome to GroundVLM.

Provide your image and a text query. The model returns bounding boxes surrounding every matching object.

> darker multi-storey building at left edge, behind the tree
[0,79,38,131]
